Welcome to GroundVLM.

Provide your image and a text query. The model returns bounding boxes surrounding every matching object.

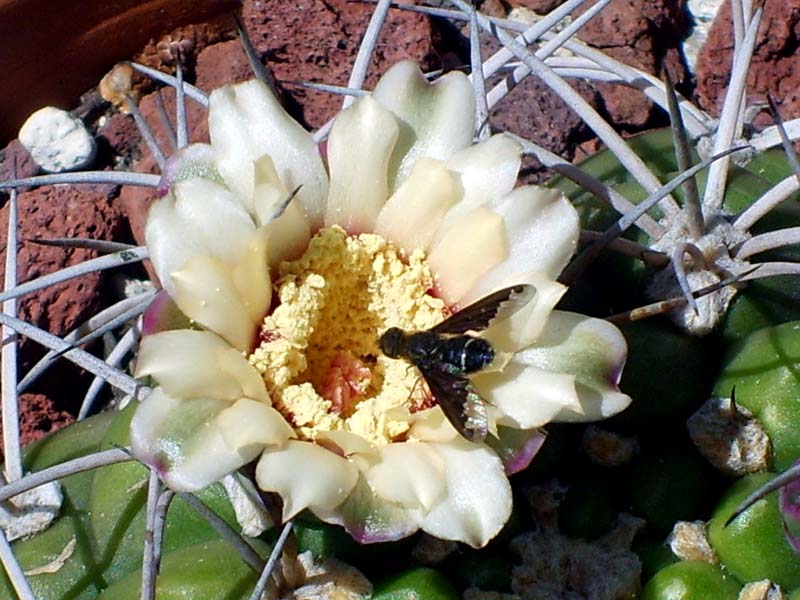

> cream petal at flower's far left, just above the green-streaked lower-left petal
[136,329,268,402]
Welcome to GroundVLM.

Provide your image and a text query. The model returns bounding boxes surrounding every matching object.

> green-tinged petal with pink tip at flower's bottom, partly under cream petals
[313,477,422,544]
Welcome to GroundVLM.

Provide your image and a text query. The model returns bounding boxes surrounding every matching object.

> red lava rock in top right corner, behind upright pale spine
[695,0,800,126]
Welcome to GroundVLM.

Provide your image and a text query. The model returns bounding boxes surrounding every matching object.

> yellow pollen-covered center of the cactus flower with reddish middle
[250,227,445,445]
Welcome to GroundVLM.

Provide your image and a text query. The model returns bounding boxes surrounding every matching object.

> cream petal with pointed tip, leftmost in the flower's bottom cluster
[256,441,358,521]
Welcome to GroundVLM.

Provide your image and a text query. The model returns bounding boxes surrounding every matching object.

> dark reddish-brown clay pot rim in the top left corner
[0,0,238,145]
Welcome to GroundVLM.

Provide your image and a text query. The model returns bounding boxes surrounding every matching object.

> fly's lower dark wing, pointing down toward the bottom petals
[417,363,489,442]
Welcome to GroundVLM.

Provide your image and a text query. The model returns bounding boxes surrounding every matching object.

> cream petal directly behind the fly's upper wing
[478,272,567,353]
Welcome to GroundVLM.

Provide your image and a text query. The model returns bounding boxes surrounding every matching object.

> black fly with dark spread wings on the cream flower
[380,284,534,442]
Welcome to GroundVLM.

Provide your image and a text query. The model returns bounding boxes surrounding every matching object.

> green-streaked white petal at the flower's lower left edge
[131,388,261,491]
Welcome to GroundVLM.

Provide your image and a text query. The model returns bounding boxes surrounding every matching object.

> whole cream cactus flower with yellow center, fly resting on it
[132,63,630,547]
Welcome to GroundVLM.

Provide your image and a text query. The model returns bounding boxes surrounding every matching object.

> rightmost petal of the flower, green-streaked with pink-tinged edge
[515,311,631,421]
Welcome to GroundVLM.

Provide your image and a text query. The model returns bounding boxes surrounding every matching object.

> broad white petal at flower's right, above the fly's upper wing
[481,185,580,289]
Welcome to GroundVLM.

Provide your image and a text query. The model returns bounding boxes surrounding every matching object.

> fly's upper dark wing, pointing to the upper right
[431,283,536,335]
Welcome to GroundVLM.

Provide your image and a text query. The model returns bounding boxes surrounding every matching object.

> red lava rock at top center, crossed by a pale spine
[242,0,435,127]
